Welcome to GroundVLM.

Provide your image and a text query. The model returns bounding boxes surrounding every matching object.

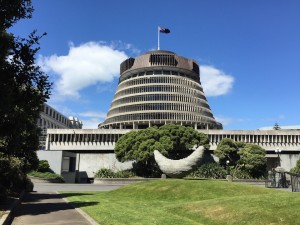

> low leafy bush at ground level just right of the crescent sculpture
[188,163,226,179]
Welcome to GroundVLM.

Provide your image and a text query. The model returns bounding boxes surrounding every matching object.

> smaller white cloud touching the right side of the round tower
[200,65,234,96]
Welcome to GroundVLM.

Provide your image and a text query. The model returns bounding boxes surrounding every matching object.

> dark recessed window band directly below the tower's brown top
[119,70,199,84]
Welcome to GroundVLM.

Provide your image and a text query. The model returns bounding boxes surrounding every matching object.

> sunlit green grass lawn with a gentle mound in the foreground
[63,179,300,225]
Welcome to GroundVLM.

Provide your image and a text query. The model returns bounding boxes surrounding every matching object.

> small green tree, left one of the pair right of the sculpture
[214,138,241,166]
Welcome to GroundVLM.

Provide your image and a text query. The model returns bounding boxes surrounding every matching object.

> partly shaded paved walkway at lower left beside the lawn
[12,192,97,225]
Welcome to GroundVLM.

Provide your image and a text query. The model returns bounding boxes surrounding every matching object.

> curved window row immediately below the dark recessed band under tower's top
[117,76,203,92]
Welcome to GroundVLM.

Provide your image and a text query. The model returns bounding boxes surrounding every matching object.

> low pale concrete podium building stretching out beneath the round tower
[43,129,300,181]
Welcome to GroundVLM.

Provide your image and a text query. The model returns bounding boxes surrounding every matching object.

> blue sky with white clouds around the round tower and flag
[11,0,300,129]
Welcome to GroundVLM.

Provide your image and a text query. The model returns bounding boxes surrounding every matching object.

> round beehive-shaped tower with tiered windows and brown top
[99,50,222,129]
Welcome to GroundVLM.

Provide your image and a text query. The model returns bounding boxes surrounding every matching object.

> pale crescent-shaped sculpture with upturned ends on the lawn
[154,146,204,178]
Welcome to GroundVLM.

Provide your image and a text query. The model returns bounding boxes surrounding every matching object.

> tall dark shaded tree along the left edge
[0,0,51,172]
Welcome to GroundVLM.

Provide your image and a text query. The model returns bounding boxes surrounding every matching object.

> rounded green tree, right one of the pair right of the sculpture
[238,144,267,178]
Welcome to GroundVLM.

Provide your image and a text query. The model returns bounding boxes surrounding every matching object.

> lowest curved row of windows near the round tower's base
[105,112,215,124]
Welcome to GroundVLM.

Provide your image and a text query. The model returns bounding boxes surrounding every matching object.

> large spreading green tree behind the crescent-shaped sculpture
[115,124,209,177]
